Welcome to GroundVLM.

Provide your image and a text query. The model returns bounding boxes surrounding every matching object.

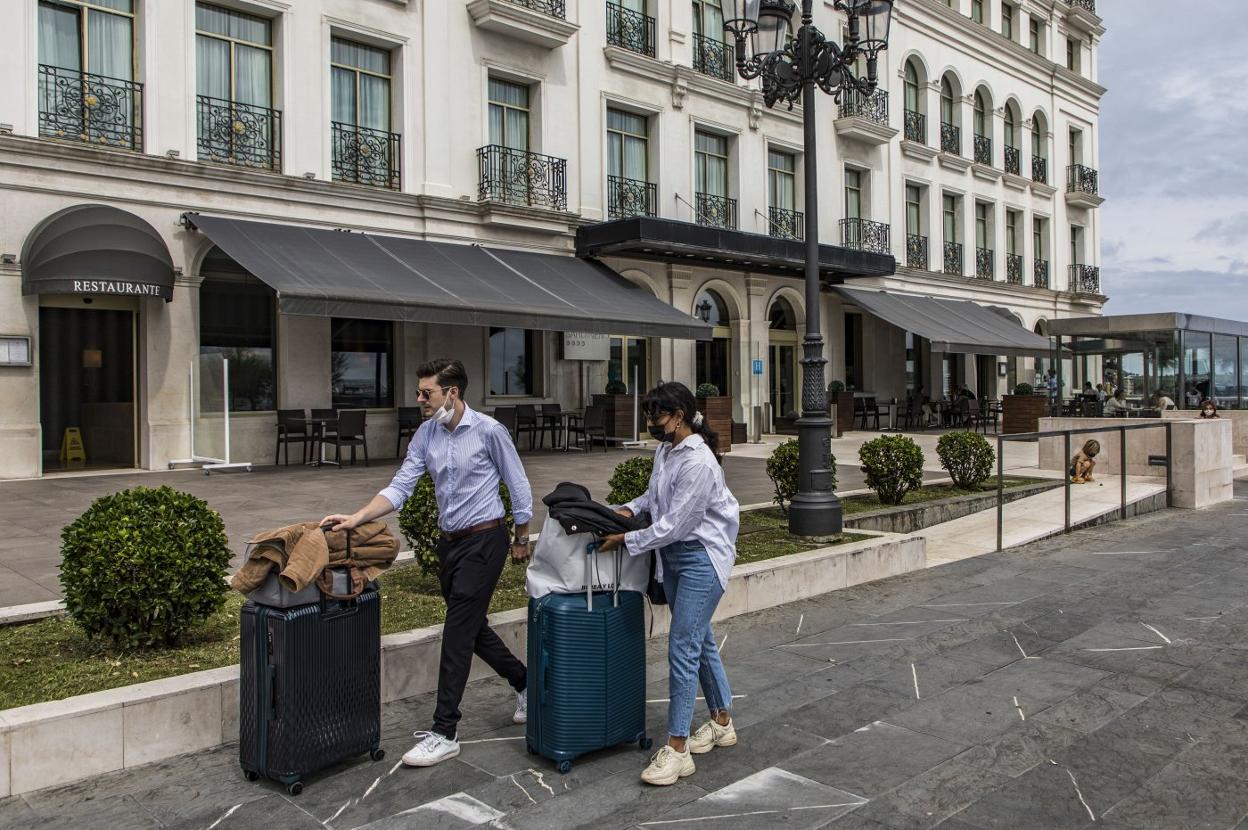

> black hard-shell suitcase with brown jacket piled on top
[238,584,384,795]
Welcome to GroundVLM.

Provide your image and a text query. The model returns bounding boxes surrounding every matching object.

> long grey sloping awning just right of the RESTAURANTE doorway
[186,213,711,339]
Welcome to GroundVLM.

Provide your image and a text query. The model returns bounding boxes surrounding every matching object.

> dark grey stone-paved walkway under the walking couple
[0,484,1248,830]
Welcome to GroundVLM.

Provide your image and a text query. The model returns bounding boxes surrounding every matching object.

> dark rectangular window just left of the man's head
[329,317,394,409]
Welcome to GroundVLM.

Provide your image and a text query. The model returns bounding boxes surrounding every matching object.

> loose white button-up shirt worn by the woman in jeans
[624,434,741,590]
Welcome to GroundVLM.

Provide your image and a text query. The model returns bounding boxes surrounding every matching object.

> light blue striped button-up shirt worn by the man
[381,403,533,530]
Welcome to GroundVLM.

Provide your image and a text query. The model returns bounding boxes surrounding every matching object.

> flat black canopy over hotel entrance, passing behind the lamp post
[577,216,897,283]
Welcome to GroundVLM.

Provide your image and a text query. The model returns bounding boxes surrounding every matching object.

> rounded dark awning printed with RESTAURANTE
[21,205,173,302]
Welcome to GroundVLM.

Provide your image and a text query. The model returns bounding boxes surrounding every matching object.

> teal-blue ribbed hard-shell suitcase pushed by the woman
[525,544,650,773]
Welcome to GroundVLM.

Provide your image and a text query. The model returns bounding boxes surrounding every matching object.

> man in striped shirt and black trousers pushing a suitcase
[321,358,533,766]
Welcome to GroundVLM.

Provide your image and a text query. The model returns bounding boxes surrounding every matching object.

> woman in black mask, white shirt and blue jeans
[602,383,740,786]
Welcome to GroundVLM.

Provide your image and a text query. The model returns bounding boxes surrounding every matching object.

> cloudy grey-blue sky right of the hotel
[1097,0,1248,321]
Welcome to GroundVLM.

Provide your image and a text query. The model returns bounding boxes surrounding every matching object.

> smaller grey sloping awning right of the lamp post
[835,286,1052,357]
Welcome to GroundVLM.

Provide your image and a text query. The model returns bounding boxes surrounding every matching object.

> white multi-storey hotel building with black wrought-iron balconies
[0,0,1104,478]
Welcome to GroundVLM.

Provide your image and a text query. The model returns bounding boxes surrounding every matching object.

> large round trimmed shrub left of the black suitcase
[60,487,231,649]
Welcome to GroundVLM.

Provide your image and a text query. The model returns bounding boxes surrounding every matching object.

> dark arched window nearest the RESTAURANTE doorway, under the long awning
[200,248,276,412]
